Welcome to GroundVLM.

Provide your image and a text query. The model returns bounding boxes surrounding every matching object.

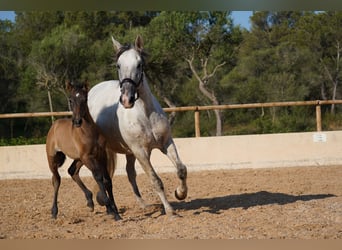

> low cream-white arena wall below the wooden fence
[0,131,342,179]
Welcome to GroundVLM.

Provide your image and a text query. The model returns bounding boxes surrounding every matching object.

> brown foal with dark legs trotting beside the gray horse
[46,82,121,220]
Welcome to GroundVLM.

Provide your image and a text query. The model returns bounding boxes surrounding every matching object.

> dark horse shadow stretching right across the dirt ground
[172,191,335,214]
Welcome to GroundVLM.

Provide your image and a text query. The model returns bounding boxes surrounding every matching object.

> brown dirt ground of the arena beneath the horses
[0,166,342,239]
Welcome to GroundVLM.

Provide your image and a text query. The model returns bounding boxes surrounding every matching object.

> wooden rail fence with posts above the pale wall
[0,100,342,137]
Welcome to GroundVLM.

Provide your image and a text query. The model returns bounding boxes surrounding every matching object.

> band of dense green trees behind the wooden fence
[0,11,342,145]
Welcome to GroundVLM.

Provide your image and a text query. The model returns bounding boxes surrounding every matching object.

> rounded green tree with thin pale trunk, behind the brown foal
[28,25,90,116]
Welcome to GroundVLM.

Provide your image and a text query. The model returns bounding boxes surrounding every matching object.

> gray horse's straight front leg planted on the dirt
[133,149,176,215]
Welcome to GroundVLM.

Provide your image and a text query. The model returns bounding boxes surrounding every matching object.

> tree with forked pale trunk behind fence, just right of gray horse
[185,12,240,136]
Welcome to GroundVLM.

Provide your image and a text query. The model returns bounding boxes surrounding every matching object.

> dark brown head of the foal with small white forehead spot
[66,81,88,127]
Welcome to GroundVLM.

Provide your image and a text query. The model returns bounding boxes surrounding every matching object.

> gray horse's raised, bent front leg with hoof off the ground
[162,138,188,200]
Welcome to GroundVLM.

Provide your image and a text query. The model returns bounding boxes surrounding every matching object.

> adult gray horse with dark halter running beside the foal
[88,36,187,215]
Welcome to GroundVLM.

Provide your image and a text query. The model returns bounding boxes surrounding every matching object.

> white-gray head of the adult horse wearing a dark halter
[112,36,144,108]
